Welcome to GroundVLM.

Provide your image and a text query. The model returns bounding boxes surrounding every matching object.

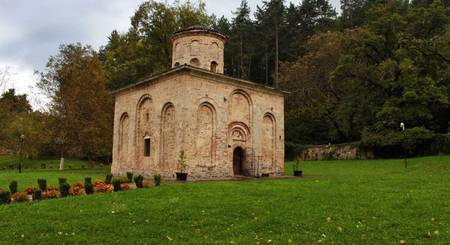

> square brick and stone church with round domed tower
[112,26,285,179]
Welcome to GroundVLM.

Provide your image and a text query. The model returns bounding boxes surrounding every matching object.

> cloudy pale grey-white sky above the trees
[0,0,339,110]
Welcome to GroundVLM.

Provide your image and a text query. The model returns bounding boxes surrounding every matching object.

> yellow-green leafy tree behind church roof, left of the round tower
[102,1,213,90]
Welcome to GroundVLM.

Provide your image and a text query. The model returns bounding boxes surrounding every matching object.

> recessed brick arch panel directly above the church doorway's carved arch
[228,89,253,125]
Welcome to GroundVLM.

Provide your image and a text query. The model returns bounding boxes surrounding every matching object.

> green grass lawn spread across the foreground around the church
[0,156,450,244]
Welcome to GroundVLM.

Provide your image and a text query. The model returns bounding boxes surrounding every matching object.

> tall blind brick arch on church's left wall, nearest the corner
[159,102,177,170]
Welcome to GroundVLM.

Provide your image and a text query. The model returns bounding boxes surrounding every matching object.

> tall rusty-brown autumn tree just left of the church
[38,44,112,157]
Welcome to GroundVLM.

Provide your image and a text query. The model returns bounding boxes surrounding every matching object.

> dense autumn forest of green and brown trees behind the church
[0,0,450,159]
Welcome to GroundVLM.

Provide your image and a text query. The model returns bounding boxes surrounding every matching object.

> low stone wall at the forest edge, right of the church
[300,143,374,161]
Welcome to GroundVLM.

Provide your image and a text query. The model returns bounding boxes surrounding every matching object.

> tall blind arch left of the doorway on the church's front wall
[196,102,217,166]
